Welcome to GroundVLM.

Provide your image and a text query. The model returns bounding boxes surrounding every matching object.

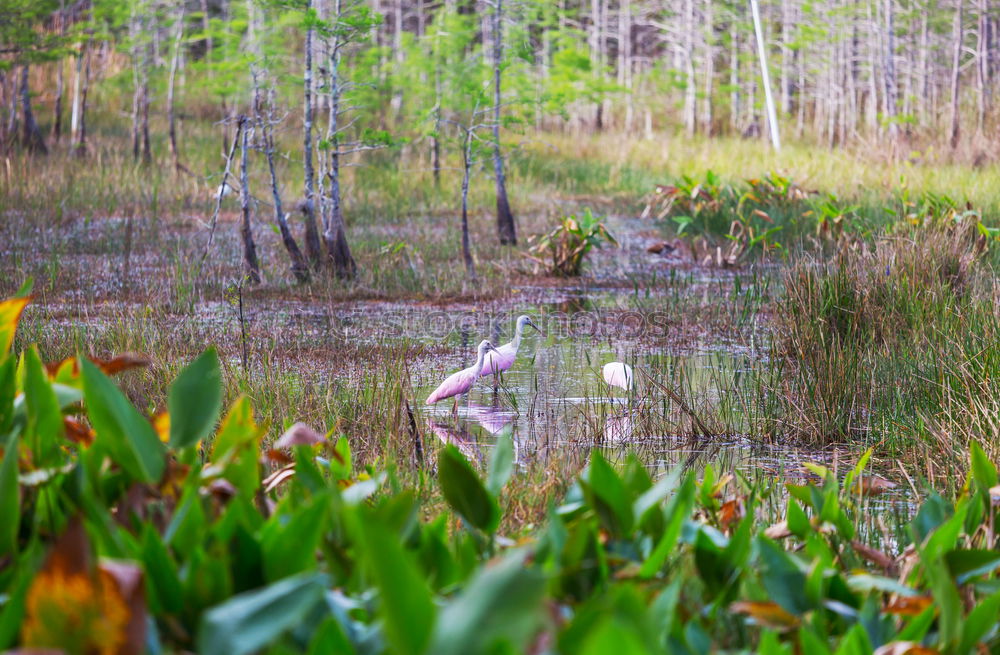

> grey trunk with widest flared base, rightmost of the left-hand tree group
[323,0,357,278]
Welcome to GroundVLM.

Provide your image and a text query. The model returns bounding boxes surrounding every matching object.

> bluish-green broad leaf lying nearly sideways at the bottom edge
[192,573,327,655]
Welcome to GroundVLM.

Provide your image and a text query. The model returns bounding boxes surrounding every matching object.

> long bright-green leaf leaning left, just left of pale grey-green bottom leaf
[353,508,435,655]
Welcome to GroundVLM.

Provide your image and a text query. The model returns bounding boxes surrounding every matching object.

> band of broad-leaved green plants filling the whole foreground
[0,298,1000,655]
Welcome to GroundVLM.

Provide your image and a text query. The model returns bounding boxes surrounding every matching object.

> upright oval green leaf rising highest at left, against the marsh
[167,348,222,449]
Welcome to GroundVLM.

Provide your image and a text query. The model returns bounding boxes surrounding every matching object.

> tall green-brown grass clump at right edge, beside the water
[771,217,1000,452]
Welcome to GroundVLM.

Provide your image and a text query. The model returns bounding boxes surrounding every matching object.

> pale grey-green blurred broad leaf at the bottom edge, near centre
[429,552,545,655]
